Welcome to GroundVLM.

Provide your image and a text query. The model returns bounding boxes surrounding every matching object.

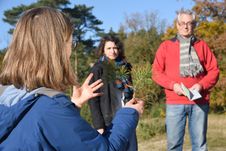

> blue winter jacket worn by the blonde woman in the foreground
[0,86,139,151]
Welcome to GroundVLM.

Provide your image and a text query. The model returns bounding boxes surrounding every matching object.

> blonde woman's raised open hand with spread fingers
[71,73,103,108]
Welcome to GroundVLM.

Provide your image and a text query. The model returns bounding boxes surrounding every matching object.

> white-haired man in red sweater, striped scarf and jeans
[152,9,219,151]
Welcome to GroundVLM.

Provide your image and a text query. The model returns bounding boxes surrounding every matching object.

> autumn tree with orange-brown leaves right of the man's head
[193,0,226,57]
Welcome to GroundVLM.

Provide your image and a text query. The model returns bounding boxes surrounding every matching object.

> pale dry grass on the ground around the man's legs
[138,114,226,151]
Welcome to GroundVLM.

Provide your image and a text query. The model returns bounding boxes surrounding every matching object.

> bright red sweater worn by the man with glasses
[152,38,219,104]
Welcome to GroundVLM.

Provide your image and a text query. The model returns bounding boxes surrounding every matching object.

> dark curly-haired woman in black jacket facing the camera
[89,35,137,151]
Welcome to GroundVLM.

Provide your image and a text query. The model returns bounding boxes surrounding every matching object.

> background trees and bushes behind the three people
[0,0,226,149]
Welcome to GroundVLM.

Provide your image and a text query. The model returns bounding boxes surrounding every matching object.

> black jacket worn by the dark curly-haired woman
[89,62,131,129]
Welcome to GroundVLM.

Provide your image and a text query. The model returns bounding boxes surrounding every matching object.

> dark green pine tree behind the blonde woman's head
[3,0,102,80]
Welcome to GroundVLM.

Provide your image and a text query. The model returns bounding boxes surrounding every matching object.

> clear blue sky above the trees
[0,0,194,49]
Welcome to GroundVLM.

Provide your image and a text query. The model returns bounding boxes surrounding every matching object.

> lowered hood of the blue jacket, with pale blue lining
[0,86,42,143]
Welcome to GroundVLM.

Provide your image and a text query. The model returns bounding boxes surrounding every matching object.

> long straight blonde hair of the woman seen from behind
[0,7,77,91]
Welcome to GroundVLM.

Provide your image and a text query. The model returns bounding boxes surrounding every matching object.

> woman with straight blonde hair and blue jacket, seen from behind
[0,7,143,151]
